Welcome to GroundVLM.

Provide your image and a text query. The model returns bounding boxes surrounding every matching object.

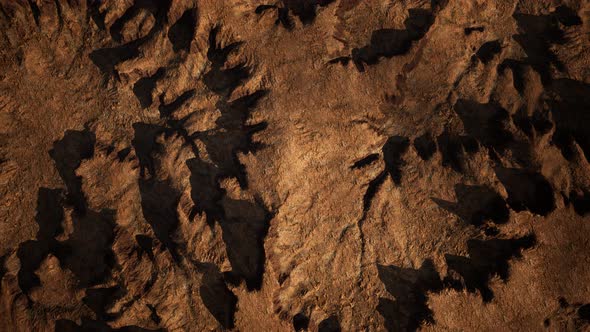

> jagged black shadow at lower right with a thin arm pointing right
[445,235,536,302]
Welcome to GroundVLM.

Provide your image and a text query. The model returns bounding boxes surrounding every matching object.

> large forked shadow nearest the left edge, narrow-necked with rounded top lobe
[22,129,115,293]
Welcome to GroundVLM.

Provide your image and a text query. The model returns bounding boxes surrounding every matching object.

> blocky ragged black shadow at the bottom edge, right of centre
[377,260,442,331]
